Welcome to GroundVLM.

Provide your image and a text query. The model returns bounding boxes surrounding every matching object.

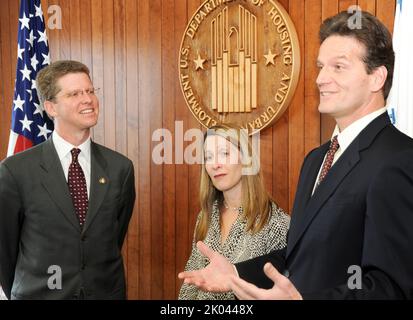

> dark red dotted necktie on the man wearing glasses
[68,148,89,226]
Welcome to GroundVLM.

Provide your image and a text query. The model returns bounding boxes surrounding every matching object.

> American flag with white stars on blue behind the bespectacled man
[7,0,53,156]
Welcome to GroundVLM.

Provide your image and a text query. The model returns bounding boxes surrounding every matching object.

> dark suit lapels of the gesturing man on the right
[286,113,390,258]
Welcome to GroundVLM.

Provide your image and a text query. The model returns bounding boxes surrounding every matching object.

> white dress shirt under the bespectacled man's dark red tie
[52,131,91,198]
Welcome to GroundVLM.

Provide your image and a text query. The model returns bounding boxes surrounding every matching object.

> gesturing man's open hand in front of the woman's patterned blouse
[178,241,237,292]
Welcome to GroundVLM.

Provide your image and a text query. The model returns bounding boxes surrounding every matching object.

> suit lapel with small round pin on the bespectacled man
[83,141,110,232]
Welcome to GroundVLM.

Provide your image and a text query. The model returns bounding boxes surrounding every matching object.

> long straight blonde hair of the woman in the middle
[195,124,272,241]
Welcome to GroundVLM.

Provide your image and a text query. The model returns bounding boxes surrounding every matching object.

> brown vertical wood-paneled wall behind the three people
[0,0,395,299]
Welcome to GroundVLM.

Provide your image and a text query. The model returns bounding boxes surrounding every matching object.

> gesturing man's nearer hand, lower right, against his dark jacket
[229,263,303,300]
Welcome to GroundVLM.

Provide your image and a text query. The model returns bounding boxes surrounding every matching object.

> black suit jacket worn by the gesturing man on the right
[237,113,413,299]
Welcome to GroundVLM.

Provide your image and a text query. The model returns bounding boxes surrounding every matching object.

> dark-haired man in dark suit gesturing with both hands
[179,12,413,299]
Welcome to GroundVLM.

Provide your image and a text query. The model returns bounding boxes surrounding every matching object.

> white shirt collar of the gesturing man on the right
[332,107,387,152]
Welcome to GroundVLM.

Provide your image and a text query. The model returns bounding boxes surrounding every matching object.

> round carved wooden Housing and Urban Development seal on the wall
[179,0,300,133]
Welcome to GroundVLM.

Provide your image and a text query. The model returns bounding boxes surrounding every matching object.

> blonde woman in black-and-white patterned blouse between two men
[179,124,290,300]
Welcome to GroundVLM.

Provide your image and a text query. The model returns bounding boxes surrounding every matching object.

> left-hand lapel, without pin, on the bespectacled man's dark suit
[40,139,80,232]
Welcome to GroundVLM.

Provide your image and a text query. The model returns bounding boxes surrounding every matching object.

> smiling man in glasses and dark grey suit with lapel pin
[0,61,135,299]
